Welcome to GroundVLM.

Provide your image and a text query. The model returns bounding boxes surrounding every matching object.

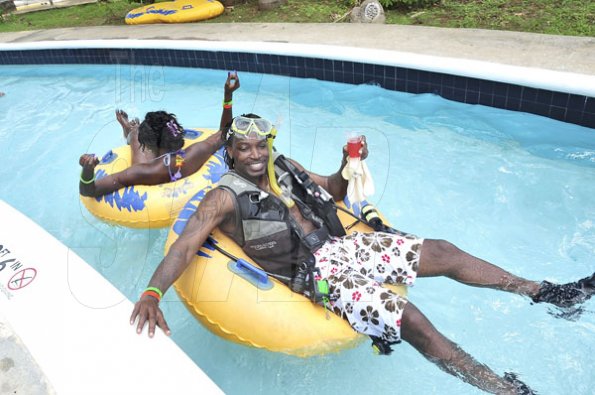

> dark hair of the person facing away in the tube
[138,111,184,153]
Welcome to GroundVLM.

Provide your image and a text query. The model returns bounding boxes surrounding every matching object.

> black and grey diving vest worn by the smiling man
[218,155,345,277]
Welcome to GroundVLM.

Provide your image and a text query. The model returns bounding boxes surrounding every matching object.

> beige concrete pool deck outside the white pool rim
[0,23,595,393]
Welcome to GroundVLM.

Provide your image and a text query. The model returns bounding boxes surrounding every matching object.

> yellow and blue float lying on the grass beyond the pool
[124,0,225,25]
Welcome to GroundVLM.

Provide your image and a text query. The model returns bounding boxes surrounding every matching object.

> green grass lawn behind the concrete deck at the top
[0,0,595,37]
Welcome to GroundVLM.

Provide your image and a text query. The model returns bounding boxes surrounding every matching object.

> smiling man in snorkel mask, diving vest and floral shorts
[130,114,595,394]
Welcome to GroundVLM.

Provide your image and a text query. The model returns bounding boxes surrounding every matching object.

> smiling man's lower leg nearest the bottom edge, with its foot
[401,302,534,395]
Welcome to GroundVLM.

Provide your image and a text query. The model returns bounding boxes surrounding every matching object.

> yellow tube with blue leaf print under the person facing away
[80,129,227,228]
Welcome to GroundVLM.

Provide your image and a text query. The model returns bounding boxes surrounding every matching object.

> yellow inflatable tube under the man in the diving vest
[165,194,407,357]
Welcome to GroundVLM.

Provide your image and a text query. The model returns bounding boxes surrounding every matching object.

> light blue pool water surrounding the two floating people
[0,66,595,394]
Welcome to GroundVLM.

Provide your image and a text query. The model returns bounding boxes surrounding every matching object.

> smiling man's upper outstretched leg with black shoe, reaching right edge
[418,239,595,307]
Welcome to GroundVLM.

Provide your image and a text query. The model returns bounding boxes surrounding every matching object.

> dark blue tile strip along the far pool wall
[0,48,595,128]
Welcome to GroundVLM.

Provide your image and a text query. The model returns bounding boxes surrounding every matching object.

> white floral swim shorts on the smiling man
[314,232,423,342]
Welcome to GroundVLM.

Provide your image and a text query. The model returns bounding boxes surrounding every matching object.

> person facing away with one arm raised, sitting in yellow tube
[79,72,240,197]
